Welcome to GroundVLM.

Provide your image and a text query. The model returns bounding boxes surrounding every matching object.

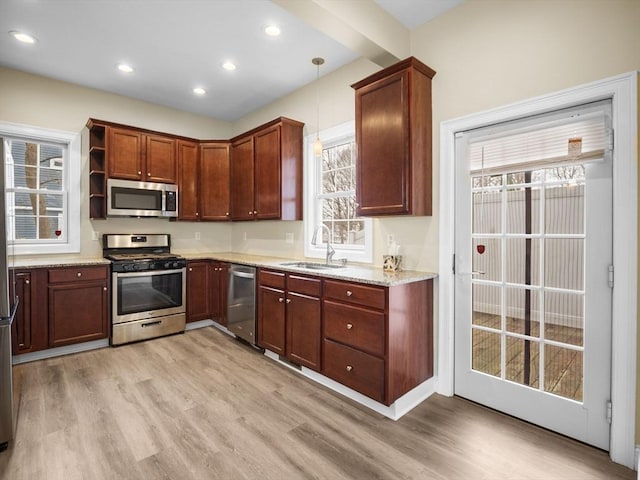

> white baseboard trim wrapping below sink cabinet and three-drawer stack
[264,350,436,420]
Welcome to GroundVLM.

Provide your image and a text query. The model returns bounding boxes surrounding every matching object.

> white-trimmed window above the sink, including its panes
[305,122,372,262]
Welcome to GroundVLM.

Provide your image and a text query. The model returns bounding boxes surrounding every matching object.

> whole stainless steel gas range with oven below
[103,234,187,345]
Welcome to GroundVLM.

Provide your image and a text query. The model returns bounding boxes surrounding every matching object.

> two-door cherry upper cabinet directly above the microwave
[107,127,177,183]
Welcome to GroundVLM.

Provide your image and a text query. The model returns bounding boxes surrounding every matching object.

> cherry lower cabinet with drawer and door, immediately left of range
[48,266,110,347]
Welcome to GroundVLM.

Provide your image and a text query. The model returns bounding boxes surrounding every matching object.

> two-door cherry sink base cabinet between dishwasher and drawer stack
[258,270,322,371]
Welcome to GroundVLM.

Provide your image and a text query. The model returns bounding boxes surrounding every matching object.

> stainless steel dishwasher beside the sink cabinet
[227,263,256,345]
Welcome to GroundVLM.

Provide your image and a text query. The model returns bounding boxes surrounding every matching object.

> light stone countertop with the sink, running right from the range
[180,252,438,287]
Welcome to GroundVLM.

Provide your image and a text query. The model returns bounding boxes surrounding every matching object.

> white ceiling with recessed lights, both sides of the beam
[0,0,463,121]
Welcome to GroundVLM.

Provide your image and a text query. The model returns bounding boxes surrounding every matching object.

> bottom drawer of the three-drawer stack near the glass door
[324,340,384,402]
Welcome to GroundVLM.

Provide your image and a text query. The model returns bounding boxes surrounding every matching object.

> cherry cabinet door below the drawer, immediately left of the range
[49,281,109,347]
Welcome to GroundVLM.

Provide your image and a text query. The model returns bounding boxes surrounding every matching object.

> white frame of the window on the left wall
[0,122,82,255]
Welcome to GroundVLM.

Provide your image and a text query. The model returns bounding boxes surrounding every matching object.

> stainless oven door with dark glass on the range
[112,268,186,324]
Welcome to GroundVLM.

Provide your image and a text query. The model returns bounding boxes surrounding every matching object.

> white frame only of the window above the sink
[304,120,373,263]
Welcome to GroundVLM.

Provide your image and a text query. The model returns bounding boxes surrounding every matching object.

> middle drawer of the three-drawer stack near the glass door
[324,300,385,356]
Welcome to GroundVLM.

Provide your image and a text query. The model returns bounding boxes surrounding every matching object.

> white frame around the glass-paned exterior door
[436,72,638,469]
